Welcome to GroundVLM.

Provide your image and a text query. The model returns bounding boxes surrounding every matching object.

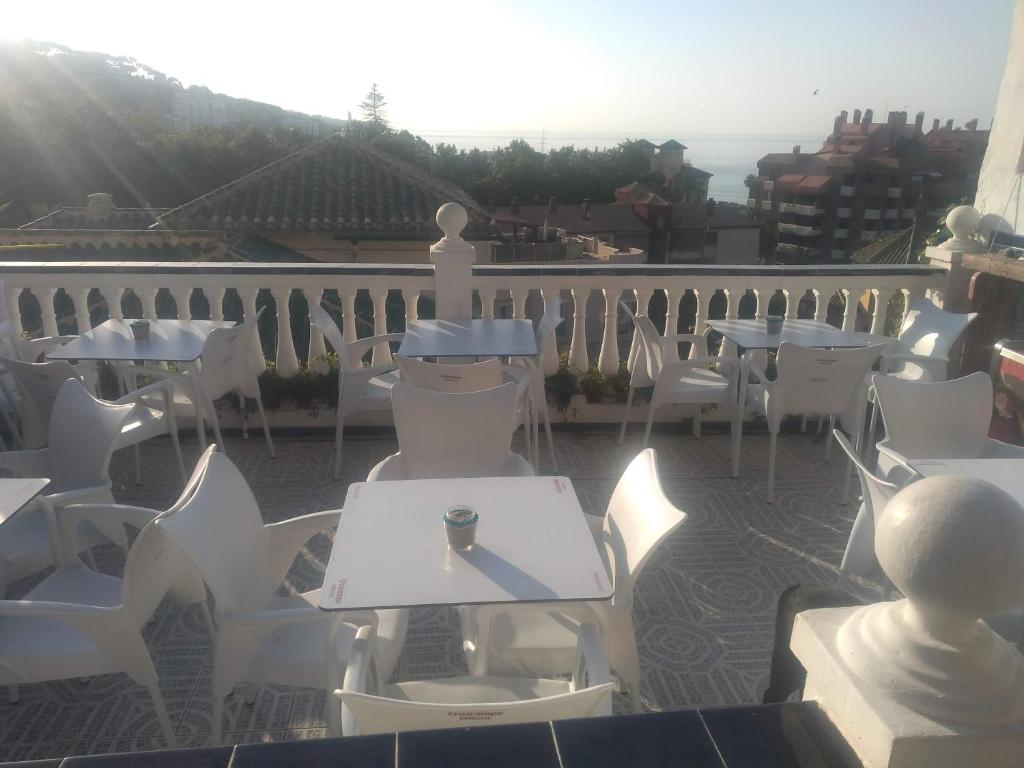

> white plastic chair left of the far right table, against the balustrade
[618,302,739,456]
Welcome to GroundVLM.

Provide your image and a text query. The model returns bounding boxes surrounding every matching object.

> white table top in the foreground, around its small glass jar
[319,477,611,610]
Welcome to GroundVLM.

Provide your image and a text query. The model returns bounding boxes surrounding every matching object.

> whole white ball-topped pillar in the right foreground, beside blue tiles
[792,476,1024,768]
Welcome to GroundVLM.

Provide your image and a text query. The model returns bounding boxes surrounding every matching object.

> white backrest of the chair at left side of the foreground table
[157,453,276,612]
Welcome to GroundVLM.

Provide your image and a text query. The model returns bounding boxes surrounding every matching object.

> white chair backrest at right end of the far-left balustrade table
[200,307,266,399]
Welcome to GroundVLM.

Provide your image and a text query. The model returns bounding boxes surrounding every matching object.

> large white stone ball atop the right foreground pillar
[876,475,1024,621]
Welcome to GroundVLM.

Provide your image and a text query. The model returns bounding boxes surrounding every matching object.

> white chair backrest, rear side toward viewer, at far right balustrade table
[773,341,887,416]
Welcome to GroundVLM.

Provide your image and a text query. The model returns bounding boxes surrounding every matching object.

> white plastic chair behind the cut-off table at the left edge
[0,379,135,587]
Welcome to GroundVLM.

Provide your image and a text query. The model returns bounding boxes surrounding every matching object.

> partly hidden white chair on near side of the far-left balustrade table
[0,357,185,483]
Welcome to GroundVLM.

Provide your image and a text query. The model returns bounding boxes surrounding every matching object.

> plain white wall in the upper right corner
[975,0,1024,232]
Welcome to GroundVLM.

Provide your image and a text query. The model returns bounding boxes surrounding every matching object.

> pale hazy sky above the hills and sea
[0,0,1012,137]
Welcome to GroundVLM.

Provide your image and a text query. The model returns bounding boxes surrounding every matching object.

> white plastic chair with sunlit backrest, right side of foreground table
[461,449,686,712]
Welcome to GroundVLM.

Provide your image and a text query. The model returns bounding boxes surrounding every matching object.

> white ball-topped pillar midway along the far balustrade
[430,203,476,321]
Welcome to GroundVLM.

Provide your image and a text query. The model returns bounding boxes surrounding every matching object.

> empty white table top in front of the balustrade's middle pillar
[398,319,537,357]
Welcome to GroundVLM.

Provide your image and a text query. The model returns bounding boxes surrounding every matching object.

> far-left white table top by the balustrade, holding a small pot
[46,319,234,362]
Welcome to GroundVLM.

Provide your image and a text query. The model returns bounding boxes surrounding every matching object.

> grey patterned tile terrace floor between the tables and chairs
[0,427,857,761]
